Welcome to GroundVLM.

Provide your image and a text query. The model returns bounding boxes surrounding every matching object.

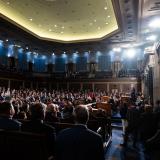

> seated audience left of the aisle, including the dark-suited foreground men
[0,88,111,160]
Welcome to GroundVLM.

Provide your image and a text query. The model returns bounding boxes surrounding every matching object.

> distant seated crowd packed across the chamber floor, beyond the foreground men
[0,87,131,119]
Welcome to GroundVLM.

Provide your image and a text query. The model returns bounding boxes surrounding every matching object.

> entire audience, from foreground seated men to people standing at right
[0,87,160,160]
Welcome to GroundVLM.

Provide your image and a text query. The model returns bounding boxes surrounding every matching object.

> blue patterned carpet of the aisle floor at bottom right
[105,129,141,160]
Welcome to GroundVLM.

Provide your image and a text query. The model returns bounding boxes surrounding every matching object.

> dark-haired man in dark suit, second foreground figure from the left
[21,103,56,156]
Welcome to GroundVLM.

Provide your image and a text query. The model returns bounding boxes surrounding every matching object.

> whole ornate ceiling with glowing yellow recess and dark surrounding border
[0,0,160,54]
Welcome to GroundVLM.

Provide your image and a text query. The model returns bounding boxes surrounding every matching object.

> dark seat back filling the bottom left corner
[0,130,48,160]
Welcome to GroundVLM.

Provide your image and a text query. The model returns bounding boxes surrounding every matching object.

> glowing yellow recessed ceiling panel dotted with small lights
[0,0,118,42]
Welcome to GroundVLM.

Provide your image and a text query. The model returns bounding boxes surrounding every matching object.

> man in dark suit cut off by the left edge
[0,102,21,130]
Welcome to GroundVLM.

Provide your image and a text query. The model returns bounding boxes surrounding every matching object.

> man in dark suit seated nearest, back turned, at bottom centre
[56,106,104,160]
